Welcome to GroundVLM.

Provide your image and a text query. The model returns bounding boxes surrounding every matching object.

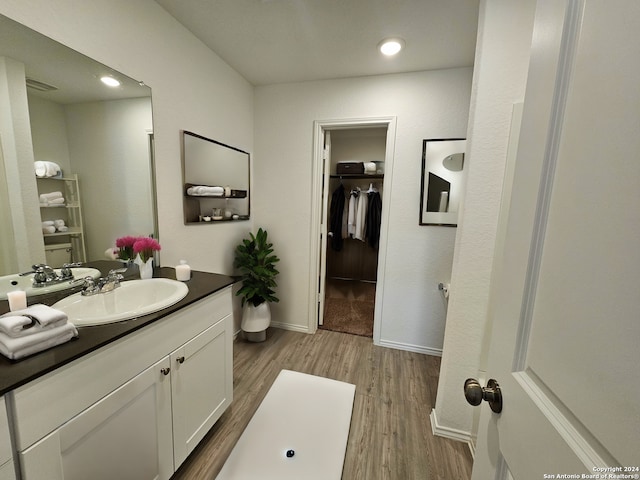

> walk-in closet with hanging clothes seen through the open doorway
[320,126,387,337]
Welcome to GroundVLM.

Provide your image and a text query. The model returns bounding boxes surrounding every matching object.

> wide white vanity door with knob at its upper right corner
[20,357,173,480]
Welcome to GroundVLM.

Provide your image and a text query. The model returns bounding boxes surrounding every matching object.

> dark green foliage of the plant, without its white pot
[234,228,280,307]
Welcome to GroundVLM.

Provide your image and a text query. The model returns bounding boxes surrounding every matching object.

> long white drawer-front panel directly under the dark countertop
[7,287,232,451]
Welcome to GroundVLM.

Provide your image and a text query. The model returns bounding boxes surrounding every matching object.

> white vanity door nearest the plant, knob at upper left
[171,315,233,469]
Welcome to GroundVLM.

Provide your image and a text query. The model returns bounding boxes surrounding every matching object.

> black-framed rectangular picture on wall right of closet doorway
[420,138,467,227]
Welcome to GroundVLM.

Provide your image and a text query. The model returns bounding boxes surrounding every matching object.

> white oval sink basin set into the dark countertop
[53,278,189,327]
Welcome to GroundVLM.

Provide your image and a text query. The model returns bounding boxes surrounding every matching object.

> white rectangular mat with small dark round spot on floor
[217,370,356,480]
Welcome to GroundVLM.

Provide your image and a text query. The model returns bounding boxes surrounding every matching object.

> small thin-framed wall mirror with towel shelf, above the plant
[181,131,250,225]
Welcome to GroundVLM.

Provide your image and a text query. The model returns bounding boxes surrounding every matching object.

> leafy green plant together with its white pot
[234,228,280,342]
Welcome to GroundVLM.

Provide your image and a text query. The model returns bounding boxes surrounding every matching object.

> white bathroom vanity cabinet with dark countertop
[0,262,234,480]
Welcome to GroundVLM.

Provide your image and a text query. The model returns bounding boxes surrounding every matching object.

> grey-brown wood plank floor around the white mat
[172,328,472,480]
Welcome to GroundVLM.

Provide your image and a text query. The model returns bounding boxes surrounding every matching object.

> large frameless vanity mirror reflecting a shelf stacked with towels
[0,15,158,274]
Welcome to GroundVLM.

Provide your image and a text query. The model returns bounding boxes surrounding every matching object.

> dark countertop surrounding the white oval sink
[0,260,236,395]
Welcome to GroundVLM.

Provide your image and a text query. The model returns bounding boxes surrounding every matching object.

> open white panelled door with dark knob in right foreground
[473,0,640,480]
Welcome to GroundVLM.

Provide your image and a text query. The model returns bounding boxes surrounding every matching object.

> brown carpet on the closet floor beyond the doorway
[320,279,376,337]
